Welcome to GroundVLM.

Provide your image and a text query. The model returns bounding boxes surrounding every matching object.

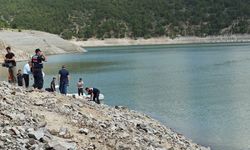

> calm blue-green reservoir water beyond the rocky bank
[1,43,250,150]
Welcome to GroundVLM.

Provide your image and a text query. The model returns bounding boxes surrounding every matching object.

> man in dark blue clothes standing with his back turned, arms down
[58,65,69,95]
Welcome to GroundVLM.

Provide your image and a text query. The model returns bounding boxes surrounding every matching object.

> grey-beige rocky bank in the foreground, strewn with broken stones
[0,82,209,150]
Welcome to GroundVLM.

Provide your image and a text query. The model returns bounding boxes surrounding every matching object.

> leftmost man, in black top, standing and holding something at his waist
[4,46,17,84]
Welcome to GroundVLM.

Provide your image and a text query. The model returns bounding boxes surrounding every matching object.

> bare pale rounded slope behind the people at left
[0,30,84,62]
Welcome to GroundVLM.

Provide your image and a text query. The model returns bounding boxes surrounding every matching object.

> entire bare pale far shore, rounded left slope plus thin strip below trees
[0,29,250,63]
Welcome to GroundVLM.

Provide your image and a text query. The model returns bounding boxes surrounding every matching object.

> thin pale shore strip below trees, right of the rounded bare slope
[70,34,250,47]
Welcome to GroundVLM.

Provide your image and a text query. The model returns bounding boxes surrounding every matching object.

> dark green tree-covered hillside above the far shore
[0,0,250,40]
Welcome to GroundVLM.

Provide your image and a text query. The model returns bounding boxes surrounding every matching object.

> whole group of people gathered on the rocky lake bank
[3,47,100,104]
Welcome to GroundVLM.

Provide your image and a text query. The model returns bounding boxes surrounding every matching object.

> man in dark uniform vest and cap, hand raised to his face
[31,48,47,90]
